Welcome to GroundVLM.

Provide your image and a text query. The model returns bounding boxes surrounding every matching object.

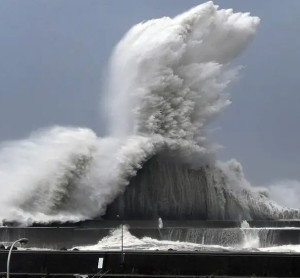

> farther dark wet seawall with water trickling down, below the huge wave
[0,221,300,250]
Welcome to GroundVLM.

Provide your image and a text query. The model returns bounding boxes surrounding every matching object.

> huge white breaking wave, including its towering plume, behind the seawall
[0,2,299,226]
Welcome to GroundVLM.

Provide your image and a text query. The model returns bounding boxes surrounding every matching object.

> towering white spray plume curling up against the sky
[104,2,259,164]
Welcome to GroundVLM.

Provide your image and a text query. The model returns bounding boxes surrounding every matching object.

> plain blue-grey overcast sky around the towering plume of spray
[0,0,300,185]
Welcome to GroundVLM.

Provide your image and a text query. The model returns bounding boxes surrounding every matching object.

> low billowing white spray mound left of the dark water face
[0,127,164,224]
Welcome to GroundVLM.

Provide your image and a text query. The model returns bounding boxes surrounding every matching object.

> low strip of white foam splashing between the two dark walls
[74,226,300,253]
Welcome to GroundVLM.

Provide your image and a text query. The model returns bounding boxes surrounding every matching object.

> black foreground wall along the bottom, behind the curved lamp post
[0,251,300,277]
